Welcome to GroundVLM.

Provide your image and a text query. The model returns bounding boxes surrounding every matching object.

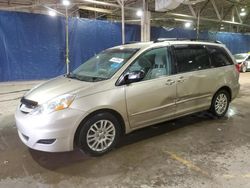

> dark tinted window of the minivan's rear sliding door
[174,45,211,73]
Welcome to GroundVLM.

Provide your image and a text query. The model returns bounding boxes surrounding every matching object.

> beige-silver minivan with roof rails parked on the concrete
[15,40,240,155]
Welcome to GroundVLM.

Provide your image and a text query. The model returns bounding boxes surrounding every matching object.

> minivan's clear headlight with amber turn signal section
[30,94,75,115]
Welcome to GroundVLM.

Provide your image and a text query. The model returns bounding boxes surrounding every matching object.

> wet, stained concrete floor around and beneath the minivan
[0,72,250,188]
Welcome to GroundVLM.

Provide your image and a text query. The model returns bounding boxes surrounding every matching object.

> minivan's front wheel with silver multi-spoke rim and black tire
[77,112,121,156]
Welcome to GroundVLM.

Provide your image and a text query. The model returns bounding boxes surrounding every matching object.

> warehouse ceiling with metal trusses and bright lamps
[0,0,250,33]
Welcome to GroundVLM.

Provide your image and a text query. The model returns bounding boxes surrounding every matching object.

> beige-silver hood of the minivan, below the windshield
[24,77,94,104]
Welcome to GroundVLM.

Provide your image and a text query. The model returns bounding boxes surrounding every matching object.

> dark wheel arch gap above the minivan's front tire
[73,108,126,148]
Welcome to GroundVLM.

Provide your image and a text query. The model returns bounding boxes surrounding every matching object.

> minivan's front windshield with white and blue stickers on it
[69,48,138,82]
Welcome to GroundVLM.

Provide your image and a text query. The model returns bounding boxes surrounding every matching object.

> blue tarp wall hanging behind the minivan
[0,11,250,81]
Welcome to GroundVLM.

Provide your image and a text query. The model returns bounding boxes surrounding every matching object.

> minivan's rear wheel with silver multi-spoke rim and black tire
[210,89,230,118]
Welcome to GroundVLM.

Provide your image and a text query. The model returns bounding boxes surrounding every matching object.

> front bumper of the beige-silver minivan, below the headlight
[15,109,83,152]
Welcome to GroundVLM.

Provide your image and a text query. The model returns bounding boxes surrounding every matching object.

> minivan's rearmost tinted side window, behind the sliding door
[207,46,233,67]
